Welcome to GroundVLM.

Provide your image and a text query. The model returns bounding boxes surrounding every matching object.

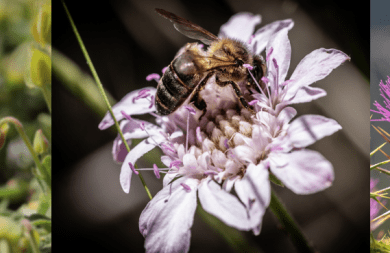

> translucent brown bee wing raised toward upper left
[156,9,219,45]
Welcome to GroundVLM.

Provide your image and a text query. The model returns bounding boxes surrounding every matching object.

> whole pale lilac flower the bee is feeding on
[99,13,349,252]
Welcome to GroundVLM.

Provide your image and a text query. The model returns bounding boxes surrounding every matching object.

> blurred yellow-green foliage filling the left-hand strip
[0,0,51,253]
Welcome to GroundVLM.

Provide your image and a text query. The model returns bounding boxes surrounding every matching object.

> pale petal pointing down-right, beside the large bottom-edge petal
[198,180,252,231]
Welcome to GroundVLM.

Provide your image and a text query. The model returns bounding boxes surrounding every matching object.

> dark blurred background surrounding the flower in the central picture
[52,0,368,252]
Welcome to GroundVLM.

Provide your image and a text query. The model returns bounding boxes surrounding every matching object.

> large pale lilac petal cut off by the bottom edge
[139,178,199,253]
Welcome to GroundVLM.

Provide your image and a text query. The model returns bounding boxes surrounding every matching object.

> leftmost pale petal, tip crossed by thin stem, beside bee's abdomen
[99,87,156,130]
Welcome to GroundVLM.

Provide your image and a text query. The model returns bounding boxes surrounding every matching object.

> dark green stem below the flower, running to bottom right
[269,191,315,253]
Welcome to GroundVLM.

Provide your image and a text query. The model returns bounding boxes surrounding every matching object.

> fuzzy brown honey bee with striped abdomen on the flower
[155,9,266,119]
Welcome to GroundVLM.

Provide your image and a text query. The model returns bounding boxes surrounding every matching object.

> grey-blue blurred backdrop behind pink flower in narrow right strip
[370,0,390,241]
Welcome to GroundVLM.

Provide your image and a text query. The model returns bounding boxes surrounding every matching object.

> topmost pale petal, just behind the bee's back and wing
[218,12,261,42]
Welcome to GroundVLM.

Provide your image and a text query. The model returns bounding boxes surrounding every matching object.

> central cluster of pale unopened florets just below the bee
[170,105,278,179]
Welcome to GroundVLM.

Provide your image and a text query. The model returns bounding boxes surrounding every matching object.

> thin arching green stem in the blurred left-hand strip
[0,117,51,193]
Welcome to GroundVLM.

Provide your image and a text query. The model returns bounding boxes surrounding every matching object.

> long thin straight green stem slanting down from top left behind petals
[62,0,153,199]
